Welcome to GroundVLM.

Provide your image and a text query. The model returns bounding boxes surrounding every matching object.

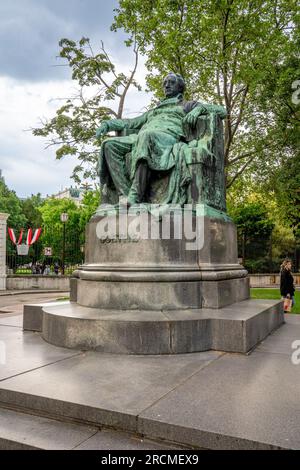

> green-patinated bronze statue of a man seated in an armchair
[96,73,226,210]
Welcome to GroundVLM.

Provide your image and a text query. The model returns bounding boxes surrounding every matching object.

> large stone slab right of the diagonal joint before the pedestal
[138,352,300,449]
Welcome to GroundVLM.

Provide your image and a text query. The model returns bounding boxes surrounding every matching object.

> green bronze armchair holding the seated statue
[110,111,226,211]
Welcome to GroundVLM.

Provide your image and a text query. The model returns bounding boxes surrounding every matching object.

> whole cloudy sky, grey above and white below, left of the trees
[0,0,150,197]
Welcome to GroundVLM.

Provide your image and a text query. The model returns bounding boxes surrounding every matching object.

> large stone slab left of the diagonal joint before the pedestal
[0,345,221,432]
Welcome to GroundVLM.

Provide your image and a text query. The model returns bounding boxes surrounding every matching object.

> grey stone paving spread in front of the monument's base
[0,293,300,449]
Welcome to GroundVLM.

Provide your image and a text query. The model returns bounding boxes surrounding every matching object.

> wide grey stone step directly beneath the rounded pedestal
[24,299,284,355]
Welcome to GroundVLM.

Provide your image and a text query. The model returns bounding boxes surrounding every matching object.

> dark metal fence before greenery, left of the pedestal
[6,224,84,275]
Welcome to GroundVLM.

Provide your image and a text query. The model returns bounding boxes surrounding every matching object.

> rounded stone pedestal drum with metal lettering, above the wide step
[72,208,249,311]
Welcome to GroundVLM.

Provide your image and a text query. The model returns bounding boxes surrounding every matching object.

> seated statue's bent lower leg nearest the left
[102,137,132,196]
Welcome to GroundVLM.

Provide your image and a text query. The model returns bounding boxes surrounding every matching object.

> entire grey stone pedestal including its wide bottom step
[24,210,283,354]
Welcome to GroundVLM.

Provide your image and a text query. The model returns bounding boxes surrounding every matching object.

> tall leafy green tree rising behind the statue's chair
[113,0,299,187]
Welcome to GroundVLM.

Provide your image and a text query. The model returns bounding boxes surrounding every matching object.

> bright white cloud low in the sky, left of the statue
[0,71,150,197]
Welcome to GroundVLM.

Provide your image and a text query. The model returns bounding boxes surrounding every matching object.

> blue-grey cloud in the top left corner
[0,0,123,80]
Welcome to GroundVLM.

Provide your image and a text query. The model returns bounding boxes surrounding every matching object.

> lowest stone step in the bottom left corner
[0,408,180,450]
